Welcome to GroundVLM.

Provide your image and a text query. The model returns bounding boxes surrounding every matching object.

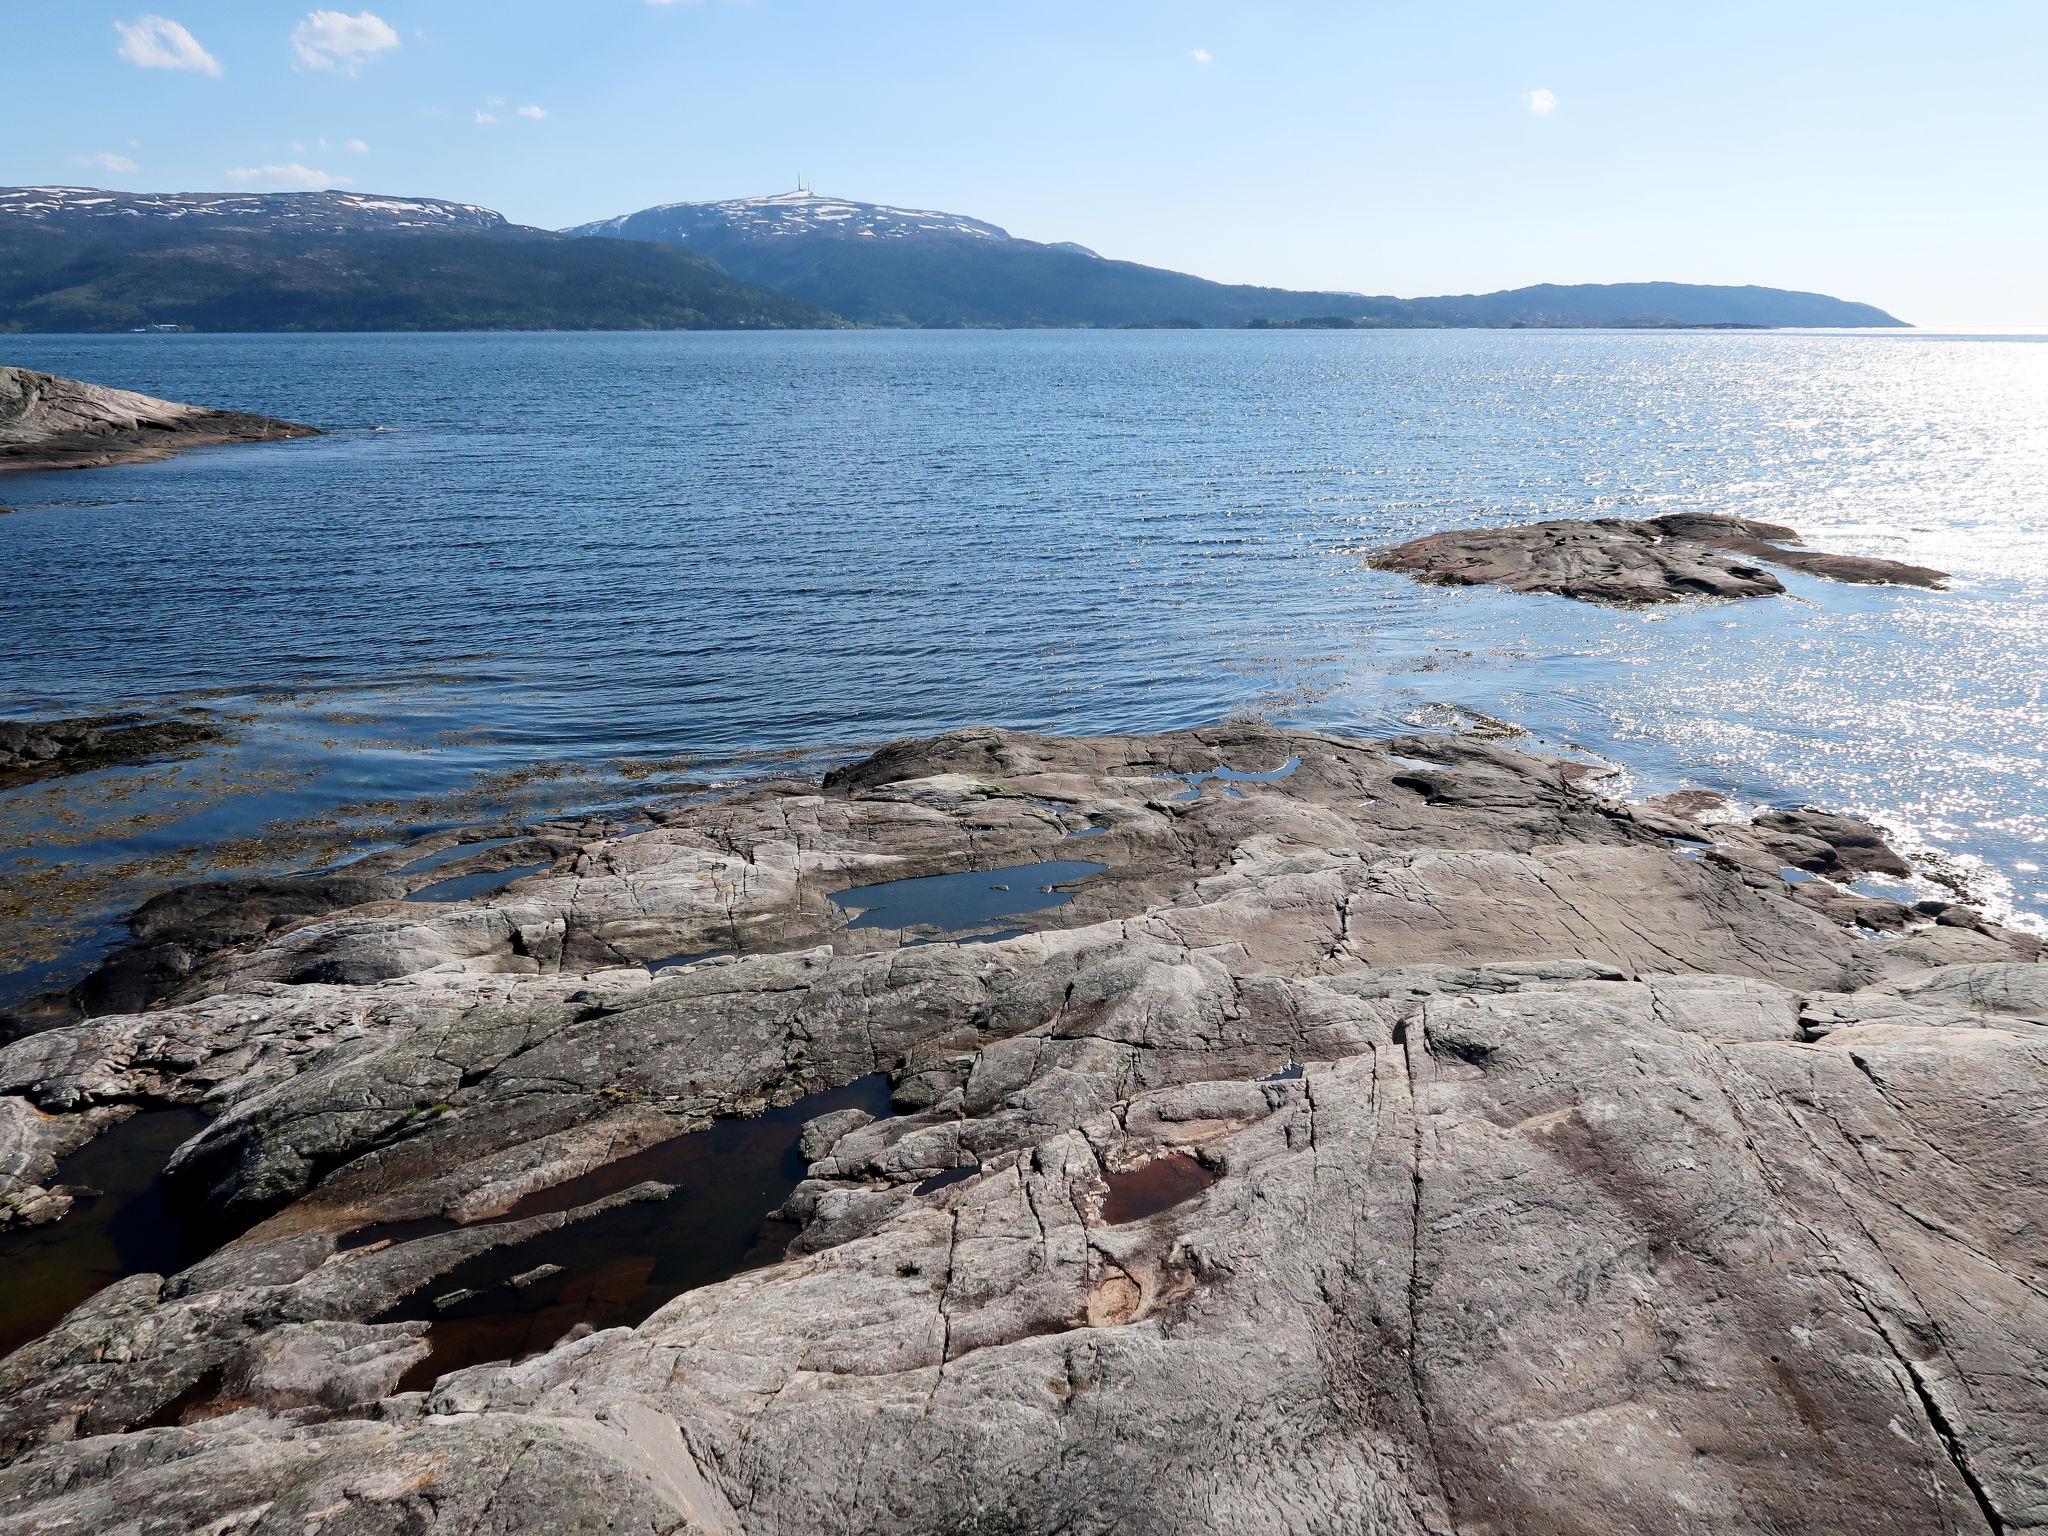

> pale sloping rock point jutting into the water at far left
[0,367,319,473]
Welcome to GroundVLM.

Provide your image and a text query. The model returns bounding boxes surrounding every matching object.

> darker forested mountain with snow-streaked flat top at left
[0,186,842,332]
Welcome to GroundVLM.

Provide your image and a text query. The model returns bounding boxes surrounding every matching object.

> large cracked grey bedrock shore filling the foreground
[0,727,2048,1536]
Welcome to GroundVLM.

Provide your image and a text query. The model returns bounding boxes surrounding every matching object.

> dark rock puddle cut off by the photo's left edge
[0,1110,209,1356]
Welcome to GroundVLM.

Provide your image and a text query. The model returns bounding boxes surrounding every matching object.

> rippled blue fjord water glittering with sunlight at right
[0,332,2048,989]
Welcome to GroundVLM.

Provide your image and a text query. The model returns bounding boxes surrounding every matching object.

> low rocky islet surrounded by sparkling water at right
[1368,512,1948,604]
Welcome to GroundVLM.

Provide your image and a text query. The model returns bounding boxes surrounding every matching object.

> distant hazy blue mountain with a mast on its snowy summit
[567,190,1903,326]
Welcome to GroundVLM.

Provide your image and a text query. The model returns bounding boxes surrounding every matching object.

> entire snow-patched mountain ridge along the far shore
[0,186,1905,332]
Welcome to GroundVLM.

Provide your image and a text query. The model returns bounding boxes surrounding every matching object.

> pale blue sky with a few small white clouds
[0,0,2048,328]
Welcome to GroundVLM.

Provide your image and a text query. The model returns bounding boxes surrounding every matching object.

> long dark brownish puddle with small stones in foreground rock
[380,1073,891,1391]
